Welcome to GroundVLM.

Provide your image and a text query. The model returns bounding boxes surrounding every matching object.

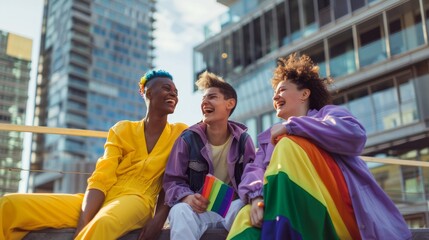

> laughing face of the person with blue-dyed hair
[146,77,179,114]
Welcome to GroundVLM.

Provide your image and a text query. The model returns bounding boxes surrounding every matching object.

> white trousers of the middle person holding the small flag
[168,199,244,240]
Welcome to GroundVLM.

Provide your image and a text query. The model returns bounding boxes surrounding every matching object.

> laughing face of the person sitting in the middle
[201,87,235,124]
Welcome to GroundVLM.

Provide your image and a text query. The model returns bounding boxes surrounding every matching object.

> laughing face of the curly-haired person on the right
[273,80,310,120]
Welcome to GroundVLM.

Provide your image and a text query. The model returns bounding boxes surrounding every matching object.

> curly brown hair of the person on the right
[271,53,332,110]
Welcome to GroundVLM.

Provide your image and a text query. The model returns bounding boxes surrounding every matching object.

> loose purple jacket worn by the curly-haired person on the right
[239,105,411,239]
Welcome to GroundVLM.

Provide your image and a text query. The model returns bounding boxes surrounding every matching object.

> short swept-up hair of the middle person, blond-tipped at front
[195,71,237,116]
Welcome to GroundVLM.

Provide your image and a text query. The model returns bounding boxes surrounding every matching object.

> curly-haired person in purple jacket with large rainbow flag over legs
[227,53,411,239]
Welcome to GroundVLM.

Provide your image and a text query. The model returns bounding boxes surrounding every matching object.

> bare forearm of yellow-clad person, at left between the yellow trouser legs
[73,189,105,238]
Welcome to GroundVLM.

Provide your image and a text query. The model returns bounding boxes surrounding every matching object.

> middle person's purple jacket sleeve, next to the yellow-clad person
[163,137,194,207]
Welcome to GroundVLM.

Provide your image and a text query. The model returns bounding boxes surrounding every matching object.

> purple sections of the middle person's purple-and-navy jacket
[163,121,255,207]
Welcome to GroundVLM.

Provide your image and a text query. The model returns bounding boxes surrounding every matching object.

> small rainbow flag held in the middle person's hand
[202,174,234,217]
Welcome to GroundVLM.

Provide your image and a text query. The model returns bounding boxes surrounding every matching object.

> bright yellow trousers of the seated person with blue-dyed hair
[0,194,153,240]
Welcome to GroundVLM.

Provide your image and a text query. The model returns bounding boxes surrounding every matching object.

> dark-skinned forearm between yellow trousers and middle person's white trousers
[138,190,170,240]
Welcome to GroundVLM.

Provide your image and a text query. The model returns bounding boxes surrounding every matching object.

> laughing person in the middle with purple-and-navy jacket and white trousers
[163,71,255,240]
